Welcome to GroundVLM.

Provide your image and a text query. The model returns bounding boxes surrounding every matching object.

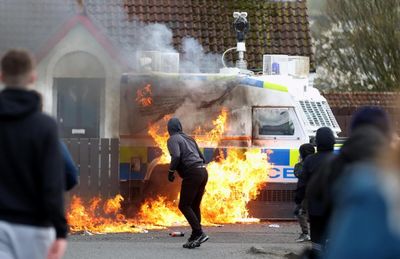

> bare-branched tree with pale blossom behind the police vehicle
[314,0,400,91]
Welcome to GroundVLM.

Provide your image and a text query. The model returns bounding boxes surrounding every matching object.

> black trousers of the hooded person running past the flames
[179,167,208,235]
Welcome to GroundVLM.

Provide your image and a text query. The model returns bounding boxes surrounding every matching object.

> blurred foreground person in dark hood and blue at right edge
[325,107,400,259]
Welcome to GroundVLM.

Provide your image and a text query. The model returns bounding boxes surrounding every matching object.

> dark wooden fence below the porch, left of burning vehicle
[64,139,120,199]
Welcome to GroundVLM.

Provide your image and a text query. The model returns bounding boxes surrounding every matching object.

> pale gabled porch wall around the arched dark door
[36,25,123,138]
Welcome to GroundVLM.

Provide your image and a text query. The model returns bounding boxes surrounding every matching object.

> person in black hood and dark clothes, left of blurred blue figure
[296,127,335,254]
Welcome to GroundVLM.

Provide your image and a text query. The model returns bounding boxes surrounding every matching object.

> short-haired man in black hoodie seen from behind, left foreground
[0,50,67,259]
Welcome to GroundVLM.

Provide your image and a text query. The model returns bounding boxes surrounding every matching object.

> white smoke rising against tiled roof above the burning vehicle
[88,0,221,73]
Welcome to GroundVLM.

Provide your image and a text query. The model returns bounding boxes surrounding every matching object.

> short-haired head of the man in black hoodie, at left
[1,49,35,86]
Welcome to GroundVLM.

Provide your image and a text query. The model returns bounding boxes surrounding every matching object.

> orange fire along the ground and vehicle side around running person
[67,109,270,233]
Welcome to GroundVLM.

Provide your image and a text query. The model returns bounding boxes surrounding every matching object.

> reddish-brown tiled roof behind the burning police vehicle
[96,0,312,68]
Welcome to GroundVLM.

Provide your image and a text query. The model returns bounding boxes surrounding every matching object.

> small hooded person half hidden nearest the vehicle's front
[294,143,315,242]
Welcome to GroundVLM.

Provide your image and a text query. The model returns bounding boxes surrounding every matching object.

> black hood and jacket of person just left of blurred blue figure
[295,127,335,215]
